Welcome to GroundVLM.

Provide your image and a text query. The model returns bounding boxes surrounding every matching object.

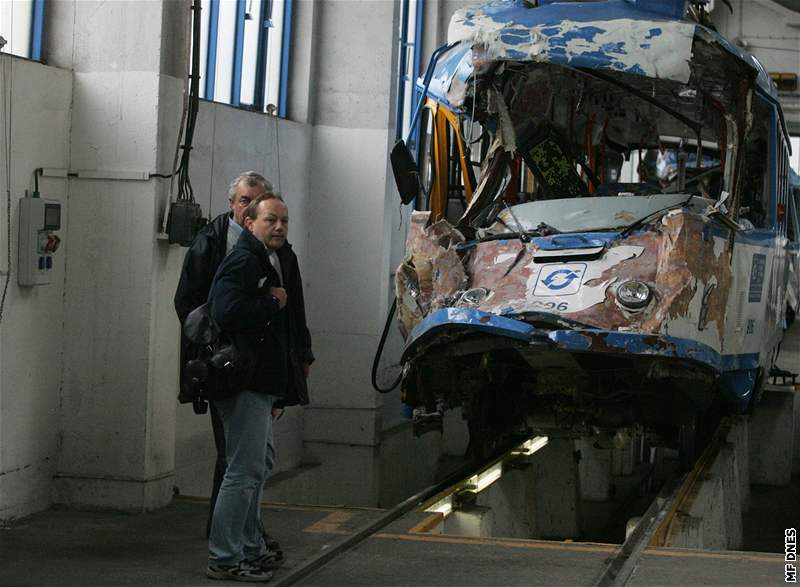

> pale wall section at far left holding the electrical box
[0,55,72,519]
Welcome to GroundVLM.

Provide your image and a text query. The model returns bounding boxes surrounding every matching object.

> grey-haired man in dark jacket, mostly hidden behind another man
[175,171,276,550]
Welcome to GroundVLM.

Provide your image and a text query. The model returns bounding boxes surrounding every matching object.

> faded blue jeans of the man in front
[208,391,275,565]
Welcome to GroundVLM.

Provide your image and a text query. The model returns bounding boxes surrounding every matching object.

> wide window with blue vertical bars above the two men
[200,0,293,117]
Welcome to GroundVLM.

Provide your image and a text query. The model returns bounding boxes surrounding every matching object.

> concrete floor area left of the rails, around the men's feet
[0,500,388,587]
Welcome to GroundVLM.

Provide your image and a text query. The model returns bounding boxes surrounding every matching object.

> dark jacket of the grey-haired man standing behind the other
[175,212,231,402]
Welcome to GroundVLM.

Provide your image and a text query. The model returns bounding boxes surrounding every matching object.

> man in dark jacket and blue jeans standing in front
[206,194,313,581]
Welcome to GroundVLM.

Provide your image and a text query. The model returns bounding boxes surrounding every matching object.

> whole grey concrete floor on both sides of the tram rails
[0,500,783,587]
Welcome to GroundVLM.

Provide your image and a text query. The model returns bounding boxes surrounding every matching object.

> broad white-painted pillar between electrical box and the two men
[46,1,189,510]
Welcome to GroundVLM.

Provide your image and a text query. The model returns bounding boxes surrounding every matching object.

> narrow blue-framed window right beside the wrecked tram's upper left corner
[395,0,425,146]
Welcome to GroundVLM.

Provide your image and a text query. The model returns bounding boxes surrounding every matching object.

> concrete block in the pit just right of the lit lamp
[529,437,581,538]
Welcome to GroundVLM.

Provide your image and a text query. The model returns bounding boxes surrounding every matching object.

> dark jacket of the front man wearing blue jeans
[208,230,314,406]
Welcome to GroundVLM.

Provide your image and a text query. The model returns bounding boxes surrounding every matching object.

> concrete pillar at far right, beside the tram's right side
[748,385,796,486]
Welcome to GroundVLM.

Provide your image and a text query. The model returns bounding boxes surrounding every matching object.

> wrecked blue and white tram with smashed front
[392,0,797,460]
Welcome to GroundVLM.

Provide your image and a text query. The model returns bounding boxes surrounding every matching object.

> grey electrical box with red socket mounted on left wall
[17,197,61,285]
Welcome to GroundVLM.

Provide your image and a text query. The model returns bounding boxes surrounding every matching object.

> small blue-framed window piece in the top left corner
[0,0,45,61]
